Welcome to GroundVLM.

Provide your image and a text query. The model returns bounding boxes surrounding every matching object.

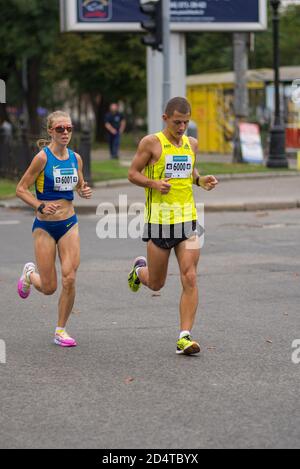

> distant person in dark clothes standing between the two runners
[105,103,126,159]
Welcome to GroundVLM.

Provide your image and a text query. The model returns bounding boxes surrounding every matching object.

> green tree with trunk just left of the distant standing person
[45,33,146,140]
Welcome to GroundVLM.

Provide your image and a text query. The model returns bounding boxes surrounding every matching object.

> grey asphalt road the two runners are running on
[0,209,300,449]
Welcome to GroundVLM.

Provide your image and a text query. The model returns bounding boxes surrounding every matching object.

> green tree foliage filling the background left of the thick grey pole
[0,0,146,122]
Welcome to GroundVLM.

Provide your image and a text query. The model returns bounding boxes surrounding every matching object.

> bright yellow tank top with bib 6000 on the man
[145,132,197,225]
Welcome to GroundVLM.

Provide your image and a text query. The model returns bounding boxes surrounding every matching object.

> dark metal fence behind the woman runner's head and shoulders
[0,127,92,183]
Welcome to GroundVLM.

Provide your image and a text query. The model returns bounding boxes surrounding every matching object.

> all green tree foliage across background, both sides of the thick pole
[0,0,300,121]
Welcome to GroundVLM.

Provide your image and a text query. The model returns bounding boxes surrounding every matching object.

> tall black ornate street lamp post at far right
[267,0,289,168]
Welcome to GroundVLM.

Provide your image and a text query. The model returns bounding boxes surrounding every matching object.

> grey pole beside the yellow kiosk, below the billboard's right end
[233,33,249,163]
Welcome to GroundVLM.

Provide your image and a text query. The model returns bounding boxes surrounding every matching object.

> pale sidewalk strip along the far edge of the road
[0,173,300,214]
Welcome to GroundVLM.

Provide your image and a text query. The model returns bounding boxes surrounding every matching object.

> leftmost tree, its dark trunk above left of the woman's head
[0,0,59,134]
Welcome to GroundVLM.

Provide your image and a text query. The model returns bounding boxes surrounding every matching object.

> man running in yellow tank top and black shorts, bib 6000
[128,97,218,355]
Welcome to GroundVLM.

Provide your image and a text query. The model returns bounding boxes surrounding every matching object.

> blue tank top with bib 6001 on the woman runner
[35,147,79,200]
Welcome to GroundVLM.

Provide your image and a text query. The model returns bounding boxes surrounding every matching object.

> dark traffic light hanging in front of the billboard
[140,0,163,51]
